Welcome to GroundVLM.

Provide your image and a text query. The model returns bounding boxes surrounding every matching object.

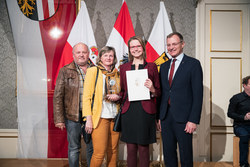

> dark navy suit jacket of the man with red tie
[159,55,203,124]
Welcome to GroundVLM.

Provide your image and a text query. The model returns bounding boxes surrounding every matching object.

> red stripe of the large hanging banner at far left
[39,0,76,158]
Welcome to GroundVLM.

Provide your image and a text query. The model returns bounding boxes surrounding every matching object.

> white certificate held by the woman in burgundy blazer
[126,69,150,101]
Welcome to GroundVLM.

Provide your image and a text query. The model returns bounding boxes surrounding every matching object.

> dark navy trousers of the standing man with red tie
[161,107,193,167]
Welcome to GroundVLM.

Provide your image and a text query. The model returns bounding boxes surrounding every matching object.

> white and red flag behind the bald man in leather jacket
[54,1,98,83]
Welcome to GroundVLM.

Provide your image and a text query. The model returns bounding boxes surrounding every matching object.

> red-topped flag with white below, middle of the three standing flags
[106,1,135,67]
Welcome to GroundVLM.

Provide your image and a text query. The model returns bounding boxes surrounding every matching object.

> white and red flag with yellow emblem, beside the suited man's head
[146,2,172,66]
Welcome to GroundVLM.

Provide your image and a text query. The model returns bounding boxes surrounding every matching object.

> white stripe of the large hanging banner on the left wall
[6,0,48,158]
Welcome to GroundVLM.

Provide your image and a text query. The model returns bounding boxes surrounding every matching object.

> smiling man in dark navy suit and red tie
[158,32,203,167]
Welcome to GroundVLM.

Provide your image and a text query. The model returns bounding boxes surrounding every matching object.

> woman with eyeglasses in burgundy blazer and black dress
[120,36,161,167]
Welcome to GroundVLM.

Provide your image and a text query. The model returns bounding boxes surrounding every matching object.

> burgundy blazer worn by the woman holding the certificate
[120,62,161,114]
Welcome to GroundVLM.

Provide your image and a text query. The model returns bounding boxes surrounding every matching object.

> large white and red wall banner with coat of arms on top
[6,0,76,158]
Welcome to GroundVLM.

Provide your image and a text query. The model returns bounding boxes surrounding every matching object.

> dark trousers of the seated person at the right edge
[234,125,250,167]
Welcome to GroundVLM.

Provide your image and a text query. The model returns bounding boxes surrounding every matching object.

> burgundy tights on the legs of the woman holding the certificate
[127,143,149,167]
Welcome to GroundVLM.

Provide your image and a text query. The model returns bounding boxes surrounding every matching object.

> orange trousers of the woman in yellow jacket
[90,118,120,167]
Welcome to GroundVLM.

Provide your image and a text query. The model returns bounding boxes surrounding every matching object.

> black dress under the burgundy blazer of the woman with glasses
[121,65,156,145]
